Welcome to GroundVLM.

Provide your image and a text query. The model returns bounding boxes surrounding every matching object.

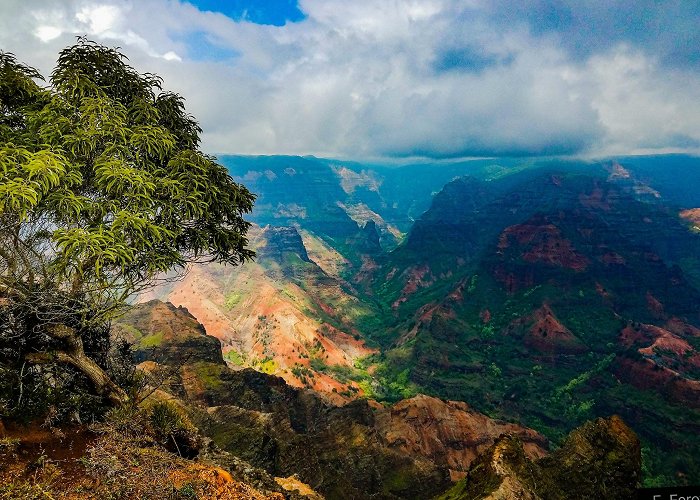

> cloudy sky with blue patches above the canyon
[0,0,700,160]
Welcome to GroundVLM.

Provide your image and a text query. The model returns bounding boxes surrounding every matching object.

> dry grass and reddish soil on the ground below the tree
[0,411,284,500]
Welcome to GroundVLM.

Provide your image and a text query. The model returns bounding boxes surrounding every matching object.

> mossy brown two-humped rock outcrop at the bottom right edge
[441,416,641,500]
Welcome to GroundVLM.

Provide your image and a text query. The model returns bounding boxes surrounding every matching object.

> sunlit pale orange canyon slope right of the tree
[137,233,374,402]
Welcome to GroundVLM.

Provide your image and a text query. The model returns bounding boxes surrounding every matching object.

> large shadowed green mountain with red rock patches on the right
[370,167,700,481]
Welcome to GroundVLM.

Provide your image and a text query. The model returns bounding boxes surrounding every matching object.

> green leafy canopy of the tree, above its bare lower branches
[0,40,253,291]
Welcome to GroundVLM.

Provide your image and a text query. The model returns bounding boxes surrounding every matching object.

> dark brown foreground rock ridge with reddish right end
[172,369,547,498]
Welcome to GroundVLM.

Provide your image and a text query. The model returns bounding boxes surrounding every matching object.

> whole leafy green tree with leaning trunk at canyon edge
[0,39,254,410]
